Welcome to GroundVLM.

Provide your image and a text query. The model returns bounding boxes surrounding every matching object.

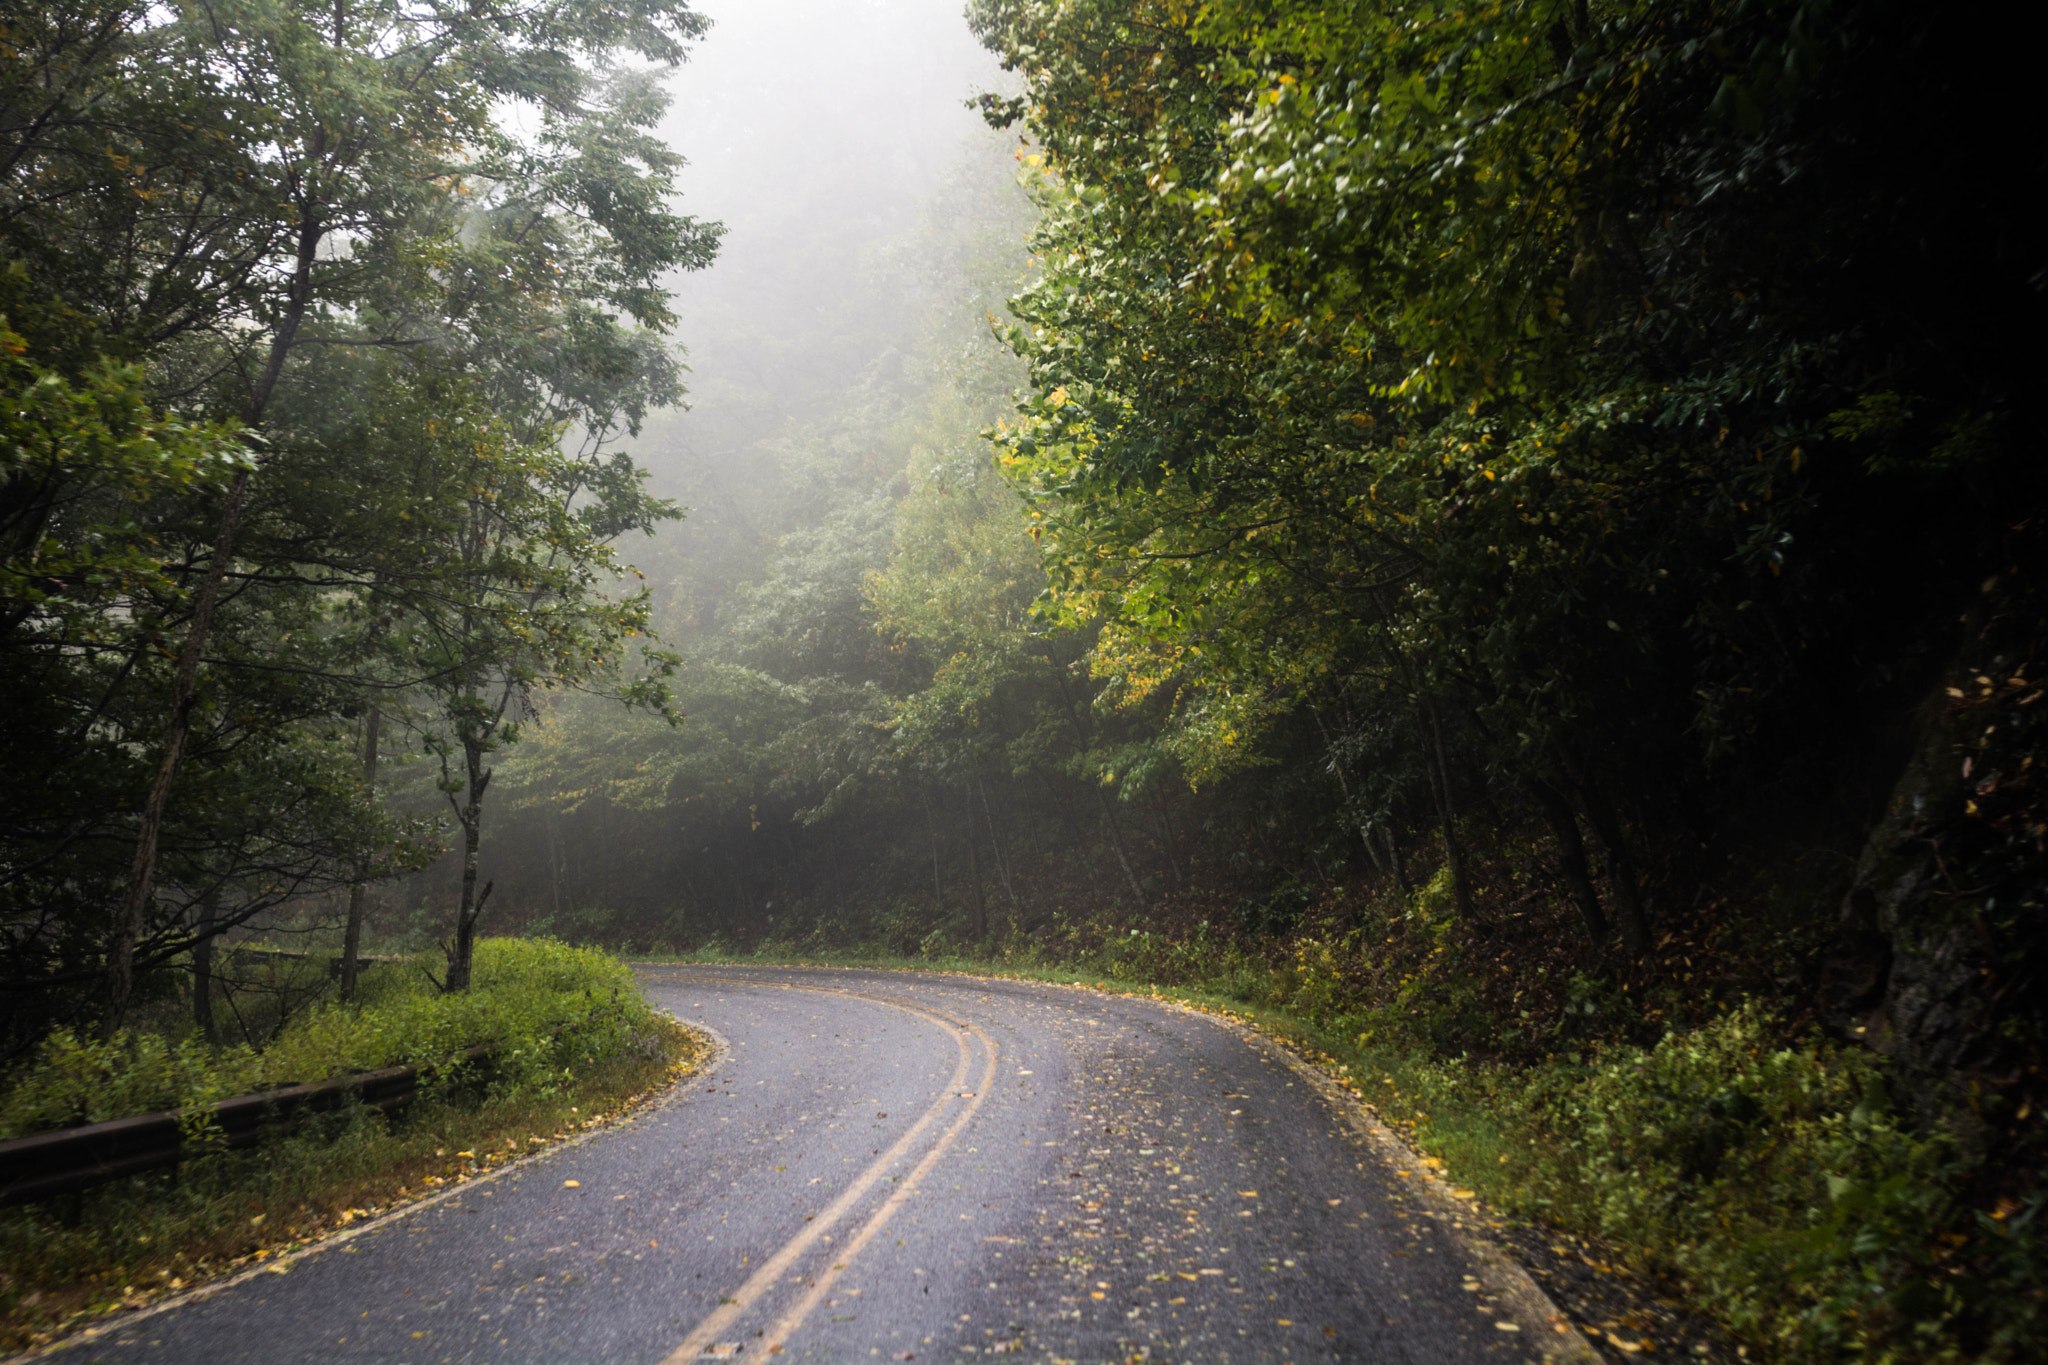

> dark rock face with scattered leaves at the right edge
[1821,573,2048,1156]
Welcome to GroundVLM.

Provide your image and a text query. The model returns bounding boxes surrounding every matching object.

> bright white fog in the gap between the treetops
[633,0,1014,564]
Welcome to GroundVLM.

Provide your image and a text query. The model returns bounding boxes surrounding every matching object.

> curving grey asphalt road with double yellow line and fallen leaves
[44,966,1591,1365]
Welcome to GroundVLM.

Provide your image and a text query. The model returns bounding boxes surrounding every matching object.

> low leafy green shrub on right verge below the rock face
[1499,1003,1952,1357]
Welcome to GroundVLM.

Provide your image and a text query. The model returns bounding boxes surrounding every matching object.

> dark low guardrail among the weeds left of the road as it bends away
[0,1046,492,1207]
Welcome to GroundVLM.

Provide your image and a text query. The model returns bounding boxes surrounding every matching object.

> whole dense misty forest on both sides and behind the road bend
[0,0,2048,1359]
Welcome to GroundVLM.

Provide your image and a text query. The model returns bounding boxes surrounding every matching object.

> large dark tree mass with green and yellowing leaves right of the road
[973,0,2038,954]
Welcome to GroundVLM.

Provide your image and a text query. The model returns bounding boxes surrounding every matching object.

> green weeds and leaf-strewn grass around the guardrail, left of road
[0,939,709,1351]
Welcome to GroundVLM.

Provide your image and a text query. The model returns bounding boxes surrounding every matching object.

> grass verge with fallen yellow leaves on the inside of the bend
[0,943,707,1351]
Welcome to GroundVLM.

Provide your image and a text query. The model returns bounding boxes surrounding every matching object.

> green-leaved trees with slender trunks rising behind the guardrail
[0,0,721,1035]
